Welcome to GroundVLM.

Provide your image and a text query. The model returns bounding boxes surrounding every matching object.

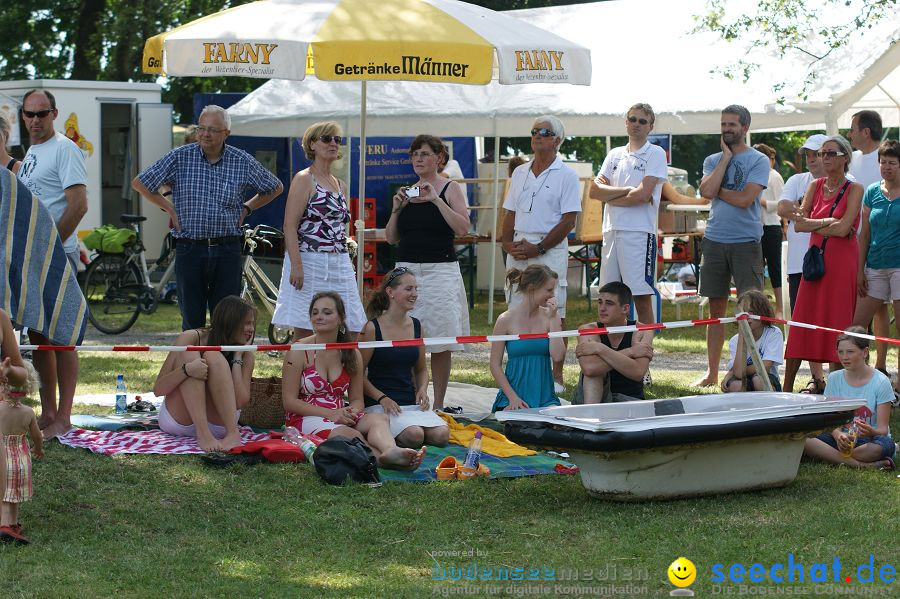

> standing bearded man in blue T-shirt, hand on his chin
[694,104,770,387]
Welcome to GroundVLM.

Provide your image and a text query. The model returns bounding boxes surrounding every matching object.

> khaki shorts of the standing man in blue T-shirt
[700,238,763,297]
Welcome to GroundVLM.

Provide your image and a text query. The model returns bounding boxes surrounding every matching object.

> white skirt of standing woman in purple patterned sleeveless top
[272,252,367,333]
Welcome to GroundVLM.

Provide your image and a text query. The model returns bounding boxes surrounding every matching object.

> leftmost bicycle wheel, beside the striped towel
[82,254,144,335]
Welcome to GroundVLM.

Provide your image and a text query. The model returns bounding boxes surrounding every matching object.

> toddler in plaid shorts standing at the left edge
[0,358,44,545]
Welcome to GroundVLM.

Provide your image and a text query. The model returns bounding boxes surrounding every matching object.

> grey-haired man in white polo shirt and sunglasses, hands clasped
[501,116,581,392]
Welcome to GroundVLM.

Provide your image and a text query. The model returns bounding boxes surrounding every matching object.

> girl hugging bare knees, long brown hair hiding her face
[153,295,256,452]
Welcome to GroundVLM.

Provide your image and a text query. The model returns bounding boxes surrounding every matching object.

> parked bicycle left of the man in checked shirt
[81,214,175,335]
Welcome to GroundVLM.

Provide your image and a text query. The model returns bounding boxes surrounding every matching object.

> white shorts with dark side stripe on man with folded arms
[600,231,656,295]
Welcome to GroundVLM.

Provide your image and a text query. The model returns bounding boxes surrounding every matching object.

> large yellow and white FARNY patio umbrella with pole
[143,0,591,291]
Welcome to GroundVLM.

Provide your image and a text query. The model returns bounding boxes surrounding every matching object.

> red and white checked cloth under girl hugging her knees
[57,427,269,455]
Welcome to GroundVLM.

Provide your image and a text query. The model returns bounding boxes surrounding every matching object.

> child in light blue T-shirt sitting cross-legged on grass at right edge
[803,326,897,470]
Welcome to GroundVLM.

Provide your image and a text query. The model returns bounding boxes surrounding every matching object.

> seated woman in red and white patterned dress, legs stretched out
[281,291,425,470]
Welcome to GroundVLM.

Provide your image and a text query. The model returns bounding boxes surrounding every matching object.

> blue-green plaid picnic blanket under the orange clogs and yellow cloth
[378,445,574,485]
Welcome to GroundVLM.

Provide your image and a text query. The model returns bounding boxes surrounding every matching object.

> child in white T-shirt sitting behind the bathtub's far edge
[722,289,784,393]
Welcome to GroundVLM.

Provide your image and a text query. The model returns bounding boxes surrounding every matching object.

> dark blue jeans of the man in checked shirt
[175,239,241,331]
